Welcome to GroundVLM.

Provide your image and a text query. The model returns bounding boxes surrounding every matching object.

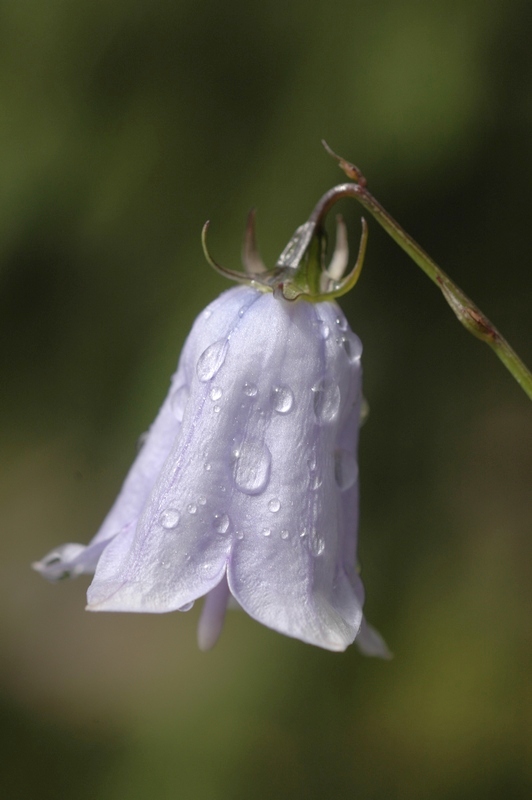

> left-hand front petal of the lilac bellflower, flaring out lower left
[88,287,261,613]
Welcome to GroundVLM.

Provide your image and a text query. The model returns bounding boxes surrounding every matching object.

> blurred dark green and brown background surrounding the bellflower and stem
[0,0,532,800]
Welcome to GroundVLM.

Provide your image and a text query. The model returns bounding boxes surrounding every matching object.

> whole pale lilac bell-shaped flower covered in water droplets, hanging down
[34,178,388,656]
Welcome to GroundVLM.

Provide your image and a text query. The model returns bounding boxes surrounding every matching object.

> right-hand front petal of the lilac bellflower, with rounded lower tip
[216,295,362,650]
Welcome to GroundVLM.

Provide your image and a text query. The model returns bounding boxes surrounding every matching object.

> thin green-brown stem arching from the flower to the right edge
[324,142,532,400]
